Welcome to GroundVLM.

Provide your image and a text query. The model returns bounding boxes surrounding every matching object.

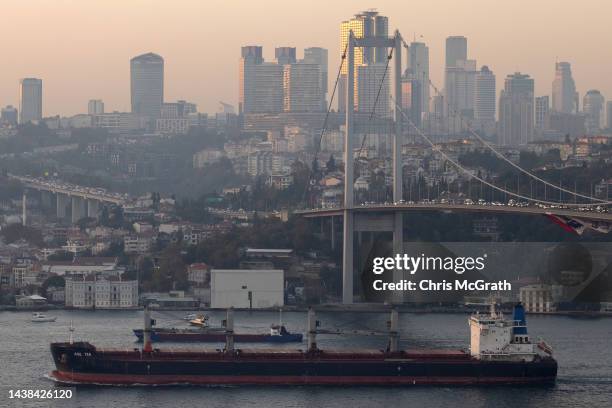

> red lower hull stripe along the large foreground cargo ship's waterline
[52,371,555,385]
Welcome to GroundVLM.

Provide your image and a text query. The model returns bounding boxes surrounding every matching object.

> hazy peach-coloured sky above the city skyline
[0,0,612,116]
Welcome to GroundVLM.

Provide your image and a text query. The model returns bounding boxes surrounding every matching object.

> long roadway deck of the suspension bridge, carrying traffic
[295,203,612,223]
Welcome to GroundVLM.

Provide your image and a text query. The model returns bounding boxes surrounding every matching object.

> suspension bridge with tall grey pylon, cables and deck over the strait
[297,30,612,304]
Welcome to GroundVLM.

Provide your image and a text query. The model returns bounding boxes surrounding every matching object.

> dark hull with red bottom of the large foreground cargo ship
[51,343,557,385]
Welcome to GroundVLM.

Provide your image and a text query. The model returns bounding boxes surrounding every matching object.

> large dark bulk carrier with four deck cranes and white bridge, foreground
[51,304,557,385]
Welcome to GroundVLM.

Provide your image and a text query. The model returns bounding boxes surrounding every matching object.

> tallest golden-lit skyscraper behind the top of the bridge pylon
[338,10,389,111]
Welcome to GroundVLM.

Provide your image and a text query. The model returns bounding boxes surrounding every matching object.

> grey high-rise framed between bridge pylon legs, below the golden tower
[356,63,391,117]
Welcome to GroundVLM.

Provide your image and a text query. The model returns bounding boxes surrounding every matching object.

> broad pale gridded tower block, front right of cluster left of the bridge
[283,62,323,112]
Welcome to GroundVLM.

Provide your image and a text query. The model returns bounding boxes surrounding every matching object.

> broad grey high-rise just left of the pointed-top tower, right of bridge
[498,72,534,146]
